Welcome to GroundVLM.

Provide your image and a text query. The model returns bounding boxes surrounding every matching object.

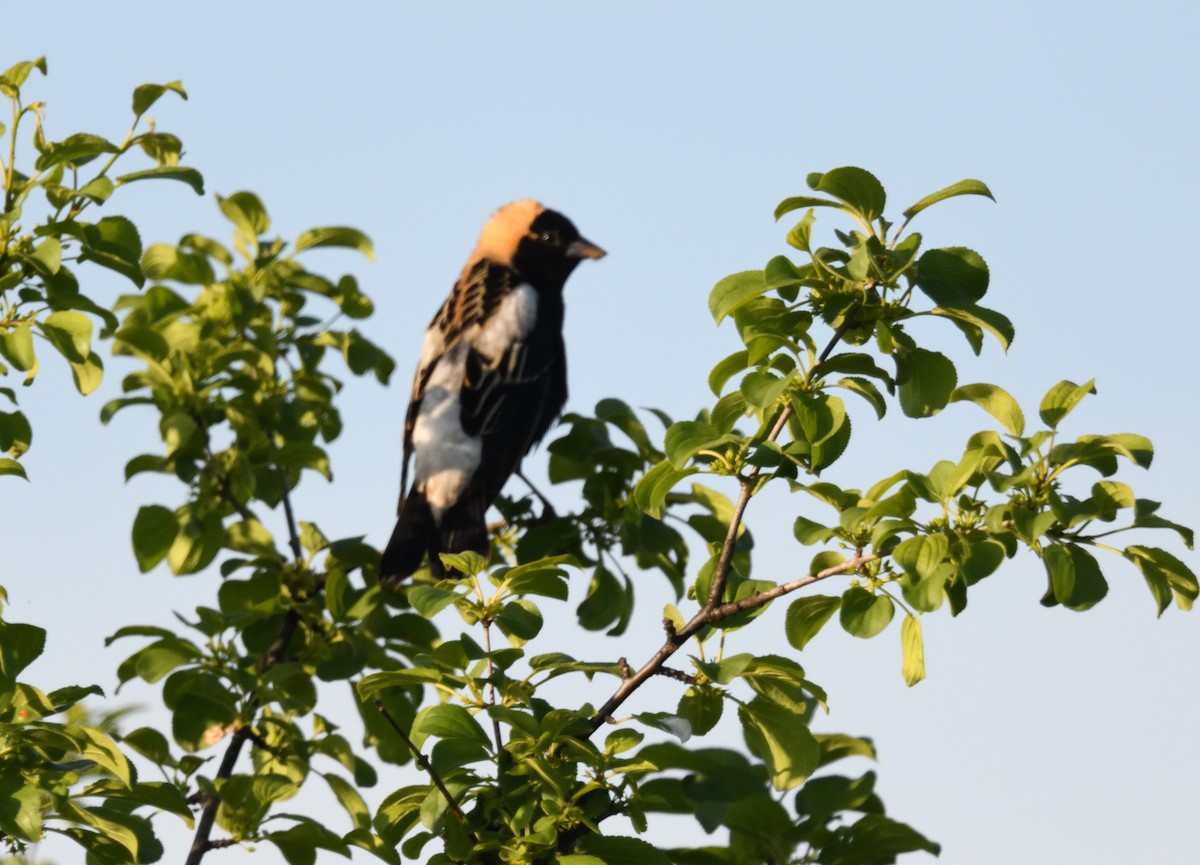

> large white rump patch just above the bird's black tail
[413,342,482,522]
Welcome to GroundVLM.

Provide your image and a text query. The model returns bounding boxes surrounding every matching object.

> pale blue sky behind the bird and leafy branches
[0,0,1200,865]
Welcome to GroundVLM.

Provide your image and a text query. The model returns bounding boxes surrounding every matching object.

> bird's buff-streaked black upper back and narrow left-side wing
[400,259,517,496]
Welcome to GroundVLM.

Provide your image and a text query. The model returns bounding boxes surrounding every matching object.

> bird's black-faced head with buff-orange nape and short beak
[472,200,605,289]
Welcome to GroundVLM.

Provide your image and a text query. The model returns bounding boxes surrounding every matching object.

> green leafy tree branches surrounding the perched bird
[0,60,1198,865]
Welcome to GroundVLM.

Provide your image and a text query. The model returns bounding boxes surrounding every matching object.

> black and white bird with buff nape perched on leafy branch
[380,200,605,581]
